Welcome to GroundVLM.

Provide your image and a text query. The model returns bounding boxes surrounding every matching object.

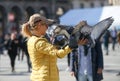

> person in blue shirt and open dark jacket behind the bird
[70,41,103,81]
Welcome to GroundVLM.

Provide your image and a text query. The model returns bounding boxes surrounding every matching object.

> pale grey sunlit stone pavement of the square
[0,45,120,81]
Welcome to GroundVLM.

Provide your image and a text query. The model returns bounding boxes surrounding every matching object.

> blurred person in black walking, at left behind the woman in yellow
[5,32,18,72]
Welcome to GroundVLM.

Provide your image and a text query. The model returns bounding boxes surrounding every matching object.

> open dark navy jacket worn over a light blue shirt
[70,41,103,81]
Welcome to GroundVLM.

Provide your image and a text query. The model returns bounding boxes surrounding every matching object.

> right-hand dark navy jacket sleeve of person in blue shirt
[95,41,104,68]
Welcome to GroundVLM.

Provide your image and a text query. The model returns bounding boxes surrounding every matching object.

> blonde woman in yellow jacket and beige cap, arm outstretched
[22,14,87,81]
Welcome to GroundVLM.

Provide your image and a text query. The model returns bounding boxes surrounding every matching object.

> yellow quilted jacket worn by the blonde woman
[27,36,71,81]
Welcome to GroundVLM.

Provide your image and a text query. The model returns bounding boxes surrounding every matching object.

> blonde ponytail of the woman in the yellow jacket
[22,23,32,37]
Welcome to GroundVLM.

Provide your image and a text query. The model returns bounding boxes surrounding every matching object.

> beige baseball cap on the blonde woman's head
[28,14,54,27]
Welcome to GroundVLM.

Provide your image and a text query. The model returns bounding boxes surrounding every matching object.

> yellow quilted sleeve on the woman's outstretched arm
[35,39,71,58]
